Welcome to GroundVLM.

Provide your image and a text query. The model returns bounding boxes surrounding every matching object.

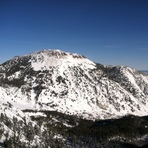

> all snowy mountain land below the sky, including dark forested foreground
[0,50,148,148]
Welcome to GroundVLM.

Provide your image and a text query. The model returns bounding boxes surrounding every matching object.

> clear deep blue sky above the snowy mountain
[0,0,148,70]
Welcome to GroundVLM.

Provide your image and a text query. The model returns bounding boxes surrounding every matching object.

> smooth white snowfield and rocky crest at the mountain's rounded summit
[30,49,95,71]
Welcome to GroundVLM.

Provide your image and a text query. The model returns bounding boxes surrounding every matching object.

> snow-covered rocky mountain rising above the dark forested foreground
[0,50,148,119]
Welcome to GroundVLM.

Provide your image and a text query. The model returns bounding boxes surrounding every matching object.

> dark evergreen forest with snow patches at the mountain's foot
[0,110,148,148]
